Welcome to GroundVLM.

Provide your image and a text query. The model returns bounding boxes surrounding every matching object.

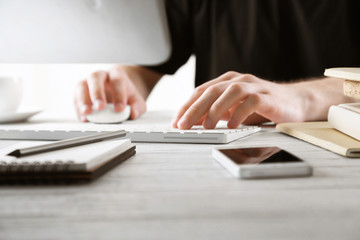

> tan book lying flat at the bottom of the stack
[276,122,360,157]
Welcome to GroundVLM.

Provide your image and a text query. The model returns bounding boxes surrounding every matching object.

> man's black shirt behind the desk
[148,0,360,86]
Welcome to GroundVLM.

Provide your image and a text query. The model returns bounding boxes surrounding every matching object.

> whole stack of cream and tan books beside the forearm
[276,68,360,157]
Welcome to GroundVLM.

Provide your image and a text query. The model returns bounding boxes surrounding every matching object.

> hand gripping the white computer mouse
[74,66,146,122]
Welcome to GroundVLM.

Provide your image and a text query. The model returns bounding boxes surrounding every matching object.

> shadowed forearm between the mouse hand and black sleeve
[124,66,163,99]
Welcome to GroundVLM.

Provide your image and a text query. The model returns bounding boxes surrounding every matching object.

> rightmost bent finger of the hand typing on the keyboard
[228,93,274,128]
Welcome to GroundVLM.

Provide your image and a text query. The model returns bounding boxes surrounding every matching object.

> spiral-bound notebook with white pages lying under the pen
[0,139,135,184]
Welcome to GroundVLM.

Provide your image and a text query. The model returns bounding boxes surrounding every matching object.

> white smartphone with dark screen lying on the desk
[212,147,312,179]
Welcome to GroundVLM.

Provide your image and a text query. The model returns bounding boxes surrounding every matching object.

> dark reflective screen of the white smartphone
[219,147,303,165]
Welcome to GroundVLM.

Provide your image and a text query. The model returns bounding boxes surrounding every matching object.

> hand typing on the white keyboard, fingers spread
[173,72,307,129]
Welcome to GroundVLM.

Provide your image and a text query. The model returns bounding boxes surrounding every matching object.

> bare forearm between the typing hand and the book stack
[289,77,356,121]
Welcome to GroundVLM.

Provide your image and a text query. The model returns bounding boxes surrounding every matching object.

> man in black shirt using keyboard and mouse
[75,0,360,129]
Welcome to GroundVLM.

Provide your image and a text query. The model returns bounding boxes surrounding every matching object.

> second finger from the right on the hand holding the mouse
[109,69,130,112]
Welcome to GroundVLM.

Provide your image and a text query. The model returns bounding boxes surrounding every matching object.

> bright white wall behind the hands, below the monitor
[0,54,195,116]
